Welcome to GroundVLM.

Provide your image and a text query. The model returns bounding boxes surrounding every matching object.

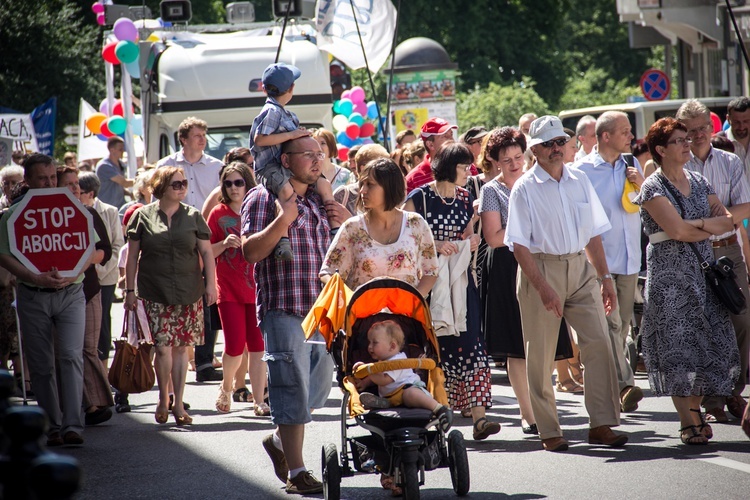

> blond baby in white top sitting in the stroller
[353,320,453,432]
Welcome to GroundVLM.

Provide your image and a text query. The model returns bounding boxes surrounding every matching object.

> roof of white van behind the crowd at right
[560,97,734,139]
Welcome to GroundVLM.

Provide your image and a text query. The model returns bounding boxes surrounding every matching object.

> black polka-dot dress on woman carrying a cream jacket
[409,183,492,410]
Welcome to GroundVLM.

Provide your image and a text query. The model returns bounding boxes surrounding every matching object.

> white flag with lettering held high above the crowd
[315,0,396,73]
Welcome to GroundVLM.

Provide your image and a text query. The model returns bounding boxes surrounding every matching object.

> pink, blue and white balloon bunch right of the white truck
[333,86,378,161]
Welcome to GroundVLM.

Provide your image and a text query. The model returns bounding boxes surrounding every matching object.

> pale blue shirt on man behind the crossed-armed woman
[685,146,750,240]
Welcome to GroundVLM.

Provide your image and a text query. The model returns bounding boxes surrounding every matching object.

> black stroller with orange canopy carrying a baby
[322,278,469,500]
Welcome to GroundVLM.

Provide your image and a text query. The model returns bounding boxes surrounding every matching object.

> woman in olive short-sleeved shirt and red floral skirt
[125,167,216,426]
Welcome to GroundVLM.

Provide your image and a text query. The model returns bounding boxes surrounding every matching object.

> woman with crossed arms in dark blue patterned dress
[635,118,740,445]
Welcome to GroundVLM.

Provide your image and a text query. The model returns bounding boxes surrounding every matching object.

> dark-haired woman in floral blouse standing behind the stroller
[320,158,438,296]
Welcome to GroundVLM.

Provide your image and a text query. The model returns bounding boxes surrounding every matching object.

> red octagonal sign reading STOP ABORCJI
[8,188,94,277]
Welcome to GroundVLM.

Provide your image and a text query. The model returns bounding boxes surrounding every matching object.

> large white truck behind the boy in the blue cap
[141,25,332,163]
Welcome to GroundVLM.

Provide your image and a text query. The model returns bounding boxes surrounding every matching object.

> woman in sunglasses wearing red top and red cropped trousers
[208,161,271,416]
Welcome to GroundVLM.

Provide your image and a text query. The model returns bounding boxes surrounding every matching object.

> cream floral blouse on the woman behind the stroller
[320,212,438,290]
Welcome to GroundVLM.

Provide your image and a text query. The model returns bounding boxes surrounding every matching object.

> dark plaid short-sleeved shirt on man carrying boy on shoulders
[241,186,331,324]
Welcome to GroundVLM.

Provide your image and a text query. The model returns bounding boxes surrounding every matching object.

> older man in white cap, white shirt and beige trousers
[505,116,628,451]
